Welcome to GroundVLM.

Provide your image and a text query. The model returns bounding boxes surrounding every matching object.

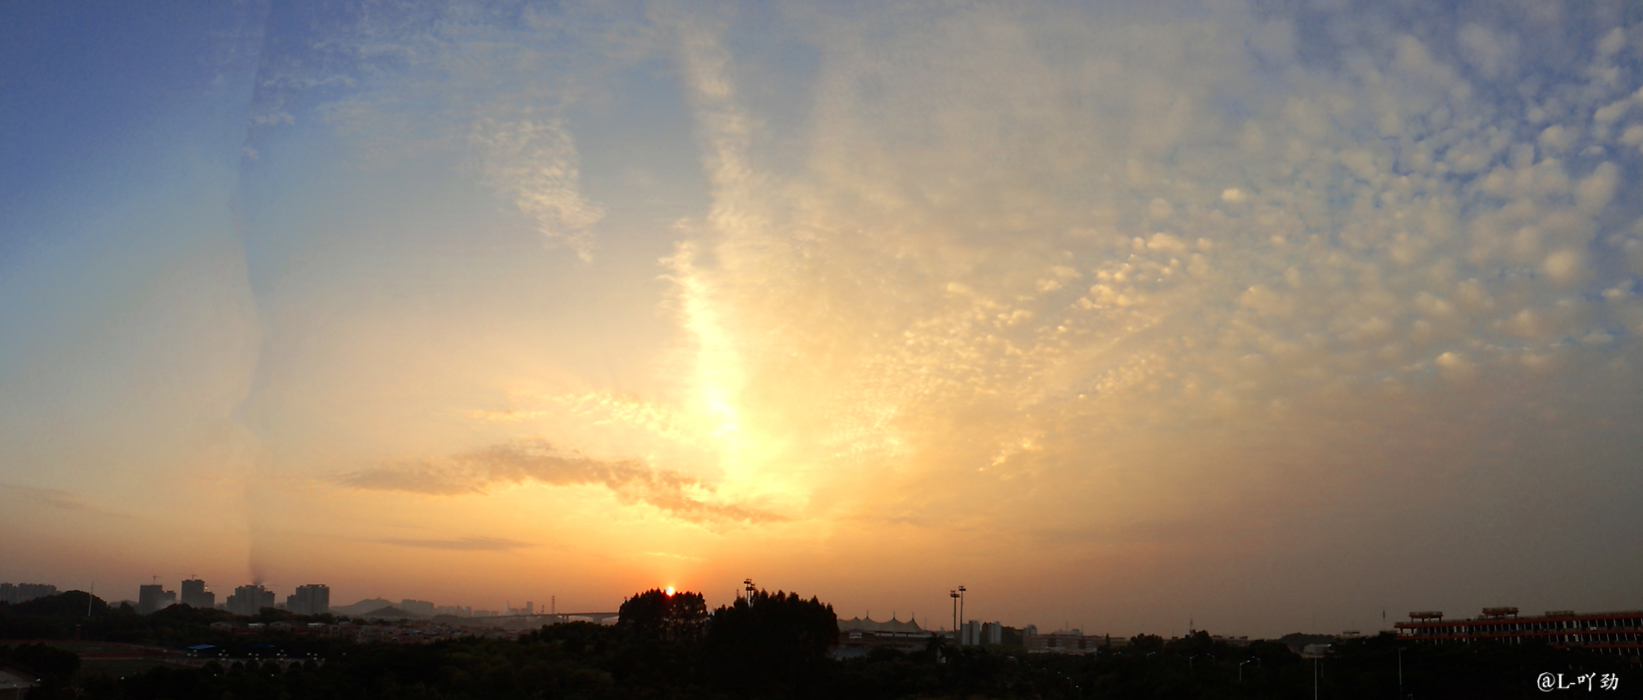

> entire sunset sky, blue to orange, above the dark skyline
[0,0,1643,636]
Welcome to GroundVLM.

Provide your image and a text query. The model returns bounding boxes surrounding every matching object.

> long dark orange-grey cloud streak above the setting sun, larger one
[335,440,785,523]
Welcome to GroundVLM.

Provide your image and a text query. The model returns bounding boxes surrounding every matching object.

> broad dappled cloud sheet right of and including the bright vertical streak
[617,0,1635,535]
